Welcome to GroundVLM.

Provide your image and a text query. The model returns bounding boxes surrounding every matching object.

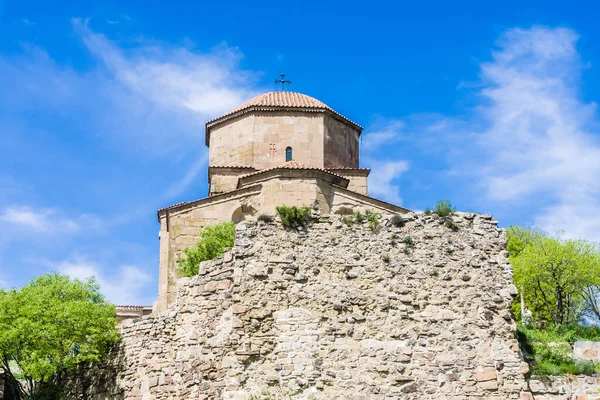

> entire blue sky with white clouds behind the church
[0,0,600,304]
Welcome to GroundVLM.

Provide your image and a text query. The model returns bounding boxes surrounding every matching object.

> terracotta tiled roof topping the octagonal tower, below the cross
[206,92,362,129]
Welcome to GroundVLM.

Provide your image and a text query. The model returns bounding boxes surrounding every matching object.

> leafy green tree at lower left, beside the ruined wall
[0,273,119,400]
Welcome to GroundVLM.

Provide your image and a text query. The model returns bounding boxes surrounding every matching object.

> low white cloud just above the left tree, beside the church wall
[56,259,155,305]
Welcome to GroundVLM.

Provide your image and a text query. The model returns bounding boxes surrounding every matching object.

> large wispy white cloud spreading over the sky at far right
[381,26,600,244]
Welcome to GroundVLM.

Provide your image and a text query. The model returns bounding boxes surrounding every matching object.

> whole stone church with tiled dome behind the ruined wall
[156,91,407,311]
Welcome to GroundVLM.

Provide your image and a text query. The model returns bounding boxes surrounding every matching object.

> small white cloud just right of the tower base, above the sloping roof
[368,160,409,204]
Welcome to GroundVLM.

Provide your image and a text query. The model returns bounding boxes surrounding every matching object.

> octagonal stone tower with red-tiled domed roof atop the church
[205,92,366,196]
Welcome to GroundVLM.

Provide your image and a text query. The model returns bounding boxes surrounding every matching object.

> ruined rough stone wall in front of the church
[119,214,526,399]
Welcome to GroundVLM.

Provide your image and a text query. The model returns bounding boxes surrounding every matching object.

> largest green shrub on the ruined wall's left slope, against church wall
[178,222,235,276]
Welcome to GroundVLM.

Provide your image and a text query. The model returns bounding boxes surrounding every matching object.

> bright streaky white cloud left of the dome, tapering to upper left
[73,19,257,120]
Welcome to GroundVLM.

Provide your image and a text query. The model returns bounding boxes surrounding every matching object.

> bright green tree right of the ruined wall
[507,227,600,325]
